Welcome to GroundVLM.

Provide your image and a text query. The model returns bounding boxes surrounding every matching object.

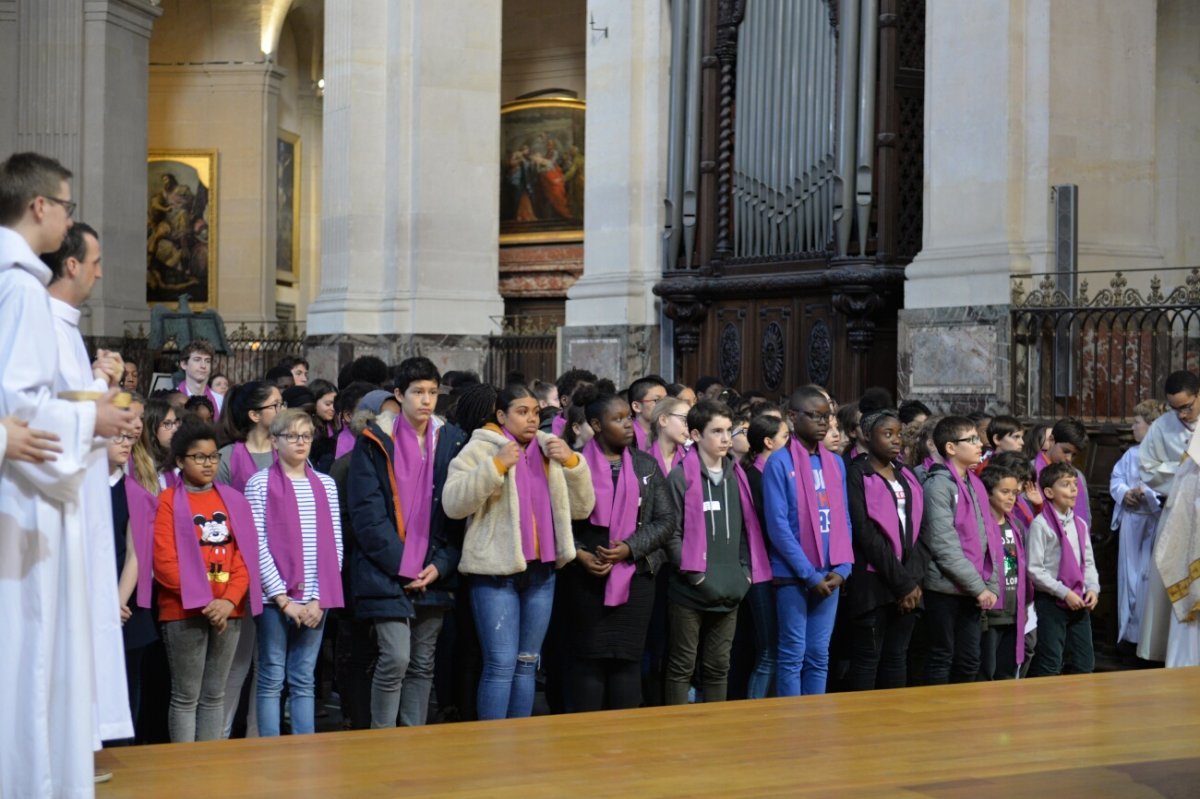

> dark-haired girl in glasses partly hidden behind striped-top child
[217,382,279,491]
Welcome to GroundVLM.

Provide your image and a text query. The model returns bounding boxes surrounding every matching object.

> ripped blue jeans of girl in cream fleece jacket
[470,563,554,721]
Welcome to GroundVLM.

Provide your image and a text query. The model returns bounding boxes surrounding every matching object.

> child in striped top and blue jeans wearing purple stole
[246,409,344,737]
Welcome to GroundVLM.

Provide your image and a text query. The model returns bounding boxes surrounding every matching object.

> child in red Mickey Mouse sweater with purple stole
[154,421,263,741]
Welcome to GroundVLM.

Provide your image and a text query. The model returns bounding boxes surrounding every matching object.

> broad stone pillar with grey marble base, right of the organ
[899,0,1162,409]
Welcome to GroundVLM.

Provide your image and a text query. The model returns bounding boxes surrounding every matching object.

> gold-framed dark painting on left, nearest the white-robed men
[146,150,217,310]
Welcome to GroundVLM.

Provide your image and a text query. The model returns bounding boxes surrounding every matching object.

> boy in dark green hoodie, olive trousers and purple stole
[665,400,770,704]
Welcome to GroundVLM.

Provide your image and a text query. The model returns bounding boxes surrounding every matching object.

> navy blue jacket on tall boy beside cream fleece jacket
[347,422,467,619]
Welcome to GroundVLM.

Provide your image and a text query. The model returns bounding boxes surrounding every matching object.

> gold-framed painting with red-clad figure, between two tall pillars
[500,97,587,244]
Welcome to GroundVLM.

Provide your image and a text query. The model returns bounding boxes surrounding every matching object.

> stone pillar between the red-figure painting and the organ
[559,0,671,385]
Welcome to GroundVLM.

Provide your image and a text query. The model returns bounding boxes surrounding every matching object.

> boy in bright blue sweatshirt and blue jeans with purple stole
[762,386,857,696]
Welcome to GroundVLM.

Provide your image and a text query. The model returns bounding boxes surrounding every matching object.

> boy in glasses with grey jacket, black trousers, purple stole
[920,416,1004,685]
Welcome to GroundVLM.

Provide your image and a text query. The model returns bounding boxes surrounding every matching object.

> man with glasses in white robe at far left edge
[0,152,133,797]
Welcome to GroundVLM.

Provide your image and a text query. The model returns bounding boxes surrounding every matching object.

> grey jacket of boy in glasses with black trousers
[920,467,1004,596]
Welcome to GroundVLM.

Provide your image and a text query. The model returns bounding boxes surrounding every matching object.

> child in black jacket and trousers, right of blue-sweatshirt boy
[846,410,930,691]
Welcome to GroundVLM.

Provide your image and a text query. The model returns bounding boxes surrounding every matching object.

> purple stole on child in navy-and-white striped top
[265,461,346,608]
